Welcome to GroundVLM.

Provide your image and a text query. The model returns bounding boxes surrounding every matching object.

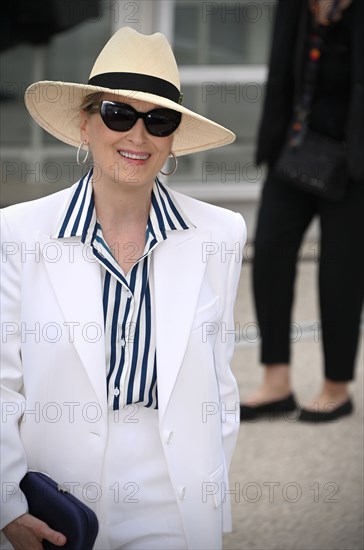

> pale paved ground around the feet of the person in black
[224,258,364,550]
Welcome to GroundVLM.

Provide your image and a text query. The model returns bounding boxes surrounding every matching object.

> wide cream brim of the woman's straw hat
[25,80,236,156]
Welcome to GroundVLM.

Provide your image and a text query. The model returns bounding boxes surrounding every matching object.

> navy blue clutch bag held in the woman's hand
[20,472,99,550]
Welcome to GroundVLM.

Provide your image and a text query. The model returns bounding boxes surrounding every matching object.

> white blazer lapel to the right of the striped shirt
[154,229,211,414]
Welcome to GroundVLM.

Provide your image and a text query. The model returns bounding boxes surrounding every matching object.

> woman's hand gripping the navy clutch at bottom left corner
[3,514,67,550]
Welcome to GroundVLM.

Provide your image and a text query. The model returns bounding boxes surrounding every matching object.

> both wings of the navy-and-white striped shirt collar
[53,169,195,244]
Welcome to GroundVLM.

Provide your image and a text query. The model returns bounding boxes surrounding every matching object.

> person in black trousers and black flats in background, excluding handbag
[240,0,364,422]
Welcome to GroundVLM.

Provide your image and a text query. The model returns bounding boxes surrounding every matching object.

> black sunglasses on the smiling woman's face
[91,101,182,137]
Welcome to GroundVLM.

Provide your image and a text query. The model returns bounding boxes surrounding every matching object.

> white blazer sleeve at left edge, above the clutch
[0,210,28,529]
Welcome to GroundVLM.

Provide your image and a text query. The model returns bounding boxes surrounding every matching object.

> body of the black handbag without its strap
[274,128,349,201]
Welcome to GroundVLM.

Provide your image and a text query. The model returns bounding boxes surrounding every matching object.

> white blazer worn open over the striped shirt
[1,186,246,549]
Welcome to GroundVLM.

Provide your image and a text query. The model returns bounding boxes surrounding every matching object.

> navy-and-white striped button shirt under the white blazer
[54,170,194,410]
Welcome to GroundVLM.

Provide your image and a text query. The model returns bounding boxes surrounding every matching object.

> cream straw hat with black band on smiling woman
[25,27,235,155]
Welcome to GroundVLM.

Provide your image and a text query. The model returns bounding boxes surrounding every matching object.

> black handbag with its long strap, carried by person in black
[274,0,349,201]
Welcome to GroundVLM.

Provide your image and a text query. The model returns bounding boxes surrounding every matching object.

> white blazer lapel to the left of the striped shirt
[41,236,107,414]
